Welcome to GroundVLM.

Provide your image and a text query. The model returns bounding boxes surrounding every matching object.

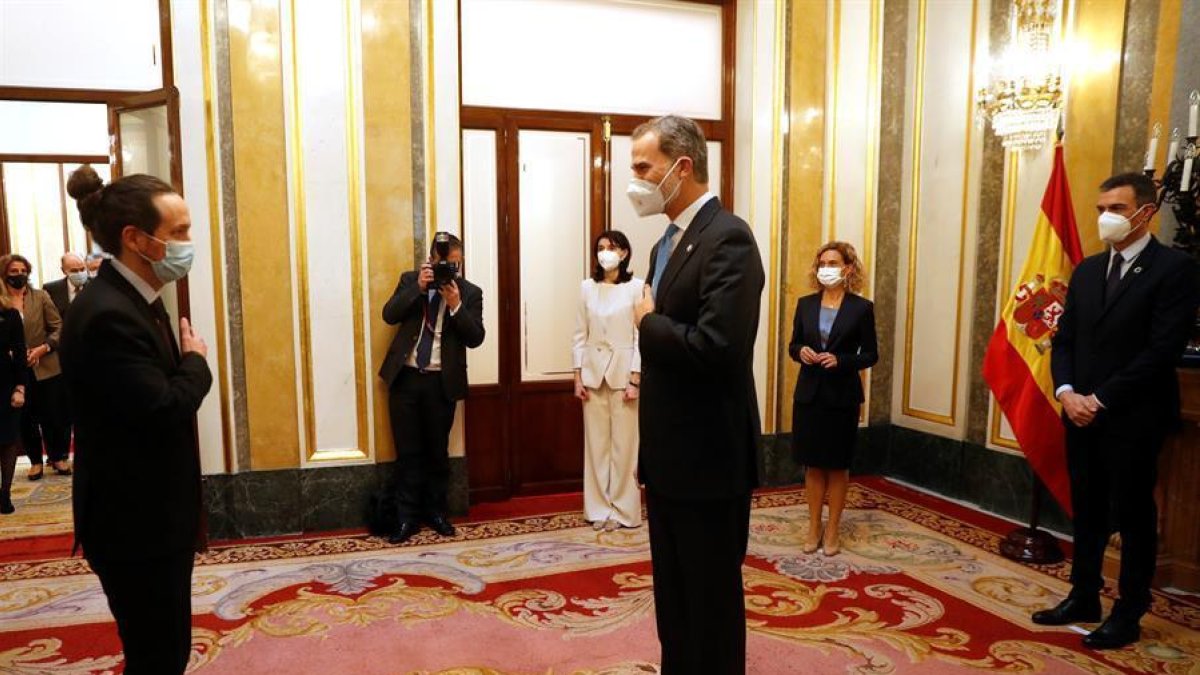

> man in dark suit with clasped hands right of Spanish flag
[1033,173,1198,649]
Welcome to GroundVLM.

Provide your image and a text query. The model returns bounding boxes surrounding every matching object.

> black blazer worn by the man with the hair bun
[61,264,212,560]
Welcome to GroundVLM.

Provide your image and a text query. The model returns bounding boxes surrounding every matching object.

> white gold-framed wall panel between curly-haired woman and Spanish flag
[894,0,986,437]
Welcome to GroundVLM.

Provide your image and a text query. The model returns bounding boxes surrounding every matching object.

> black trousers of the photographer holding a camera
[388,368,455,522]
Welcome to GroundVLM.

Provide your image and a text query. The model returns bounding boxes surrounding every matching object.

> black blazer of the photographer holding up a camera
[379,271,485,401]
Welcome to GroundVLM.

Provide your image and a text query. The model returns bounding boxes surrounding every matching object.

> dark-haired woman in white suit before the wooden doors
[572,231,644,532]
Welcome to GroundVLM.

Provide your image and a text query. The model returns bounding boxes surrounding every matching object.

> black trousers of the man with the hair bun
[88,551,194,675]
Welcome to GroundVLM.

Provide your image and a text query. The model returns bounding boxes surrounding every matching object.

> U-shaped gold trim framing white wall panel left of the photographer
[288,0,370,462]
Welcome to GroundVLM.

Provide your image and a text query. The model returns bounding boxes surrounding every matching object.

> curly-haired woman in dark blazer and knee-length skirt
[787,241,880,556]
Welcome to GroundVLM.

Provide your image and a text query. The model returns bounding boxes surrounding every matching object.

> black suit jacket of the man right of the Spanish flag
[1050,238,1200,425]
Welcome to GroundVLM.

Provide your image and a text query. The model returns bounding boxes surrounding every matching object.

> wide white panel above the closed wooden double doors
[462,0,722,119]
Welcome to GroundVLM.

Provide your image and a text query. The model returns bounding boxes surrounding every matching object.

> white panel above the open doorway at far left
[0,0,162,91]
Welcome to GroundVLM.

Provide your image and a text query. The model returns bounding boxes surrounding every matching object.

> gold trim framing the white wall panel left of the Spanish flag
[901,0,979,426]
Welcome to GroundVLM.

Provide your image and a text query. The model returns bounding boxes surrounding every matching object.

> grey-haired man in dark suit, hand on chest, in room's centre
[628,115,764,675]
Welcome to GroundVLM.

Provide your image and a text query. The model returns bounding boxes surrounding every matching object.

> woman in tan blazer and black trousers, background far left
[0,255,71,480]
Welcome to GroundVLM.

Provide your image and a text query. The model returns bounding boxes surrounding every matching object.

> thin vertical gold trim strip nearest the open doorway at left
[200,0,234,473]
